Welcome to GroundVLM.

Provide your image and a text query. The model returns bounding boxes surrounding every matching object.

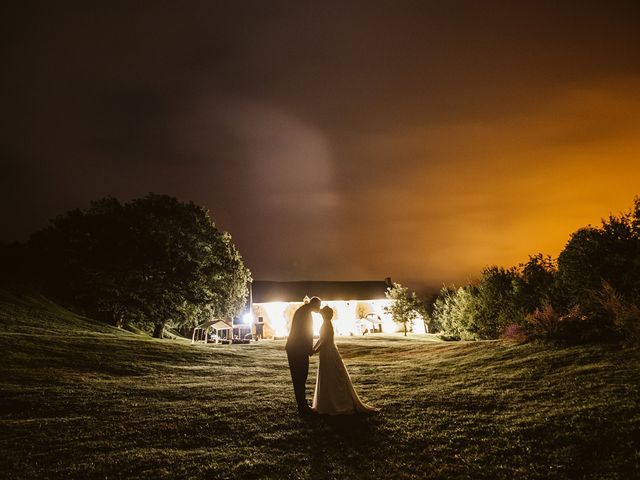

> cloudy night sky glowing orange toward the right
[0,0,640,287]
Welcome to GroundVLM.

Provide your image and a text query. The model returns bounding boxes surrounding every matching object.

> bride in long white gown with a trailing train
[312,306,378,415]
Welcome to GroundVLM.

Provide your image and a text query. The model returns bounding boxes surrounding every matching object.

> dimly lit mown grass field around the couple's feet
[0,292,640,480]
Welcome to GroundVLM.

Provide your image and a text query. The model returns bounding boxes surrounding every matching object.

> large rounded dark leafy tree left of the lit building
[30,194,251,337]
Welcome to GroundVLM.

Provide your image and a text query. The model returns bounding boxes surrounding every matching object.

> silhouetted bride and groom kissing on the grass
[285,297,377,415]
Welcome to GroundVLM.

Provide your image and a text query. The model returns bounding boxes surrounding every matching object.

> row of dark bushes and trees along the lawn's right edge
[429,197,640,345]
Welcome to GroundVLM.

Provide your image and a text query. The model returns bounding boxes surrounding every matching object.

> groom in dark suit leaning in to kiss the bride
[284,297,321,415]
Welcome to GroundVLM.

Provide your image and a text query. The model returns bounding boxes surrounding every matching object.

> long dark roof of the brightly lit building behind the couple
[251,279,391,303]
